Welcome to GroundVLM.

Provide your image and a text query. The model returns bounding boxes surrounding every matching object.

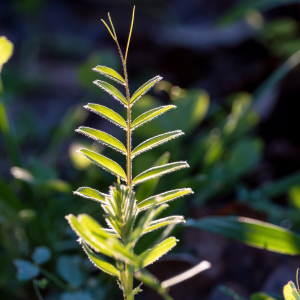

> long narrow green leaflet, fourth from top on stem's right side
[132,161,189,185]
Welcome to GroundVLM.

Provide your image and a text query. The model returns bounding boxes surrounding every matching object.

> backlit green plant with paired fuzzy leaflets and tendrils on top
[66,7,192,300]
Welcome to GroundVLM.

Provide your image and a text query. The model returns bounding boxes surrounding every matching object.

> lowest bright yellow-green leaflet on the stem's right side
[140,237,178,268]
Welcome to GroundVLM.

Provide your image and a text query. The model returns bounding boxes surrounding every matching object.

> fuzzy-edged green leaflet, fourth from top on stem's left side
[75,126,127,155]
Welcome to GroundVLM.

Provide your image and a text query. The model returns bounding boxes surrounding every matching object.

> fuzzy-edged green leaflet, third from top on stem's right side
[132,130,184,158]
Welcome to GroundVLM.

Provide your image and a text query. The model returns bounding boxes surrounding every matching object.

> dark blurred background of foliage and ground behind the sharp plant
[0,0,300,300]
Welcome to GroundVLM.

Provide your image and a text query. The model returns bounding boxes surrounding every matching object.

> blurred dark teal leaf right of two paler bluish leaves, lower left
[56,255,84,288]
